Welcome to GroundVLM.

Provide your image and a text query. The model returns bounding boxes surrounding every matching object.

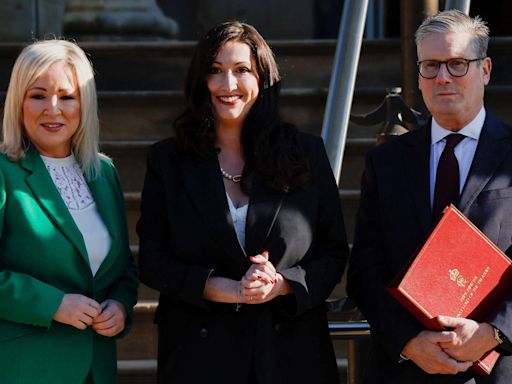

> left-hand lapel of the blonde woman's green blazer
[20,147,89,265]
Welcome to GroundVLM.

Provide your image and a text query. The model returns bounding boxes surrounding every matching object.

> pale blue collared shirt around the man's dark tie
[430,107,485,207]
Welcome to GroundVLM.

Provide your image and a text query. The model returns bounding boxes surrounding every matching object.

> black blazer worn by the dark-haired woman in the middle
[137,135,348,384]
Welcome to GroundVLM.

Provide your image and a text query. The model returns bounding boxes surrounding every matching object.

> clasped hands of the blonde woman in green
[53,293,126,337]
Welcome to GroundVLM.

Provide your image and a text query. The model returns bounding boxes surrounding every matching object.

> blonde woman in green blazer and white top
[0,40,137,384]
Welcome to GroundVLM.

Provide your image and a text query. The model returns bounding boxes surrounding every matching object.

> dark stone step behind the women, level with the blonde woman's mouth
[93,87,386,141]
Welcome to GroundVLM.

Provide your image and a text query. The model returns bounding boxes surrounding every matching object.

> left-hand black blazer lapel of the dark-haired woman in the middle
[180,153,248,263]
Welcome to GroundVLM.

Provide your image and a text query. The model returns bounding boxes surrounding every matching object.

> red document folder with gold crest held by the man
[388,206,512,374]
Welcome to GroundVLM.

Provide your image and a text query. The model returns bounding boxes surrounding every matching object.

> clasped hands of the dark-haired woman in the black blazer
[239,251,289,304]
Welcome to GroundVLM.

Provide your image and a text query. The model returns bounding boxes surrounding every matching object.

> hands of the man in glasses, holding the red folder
[402,316,497,374]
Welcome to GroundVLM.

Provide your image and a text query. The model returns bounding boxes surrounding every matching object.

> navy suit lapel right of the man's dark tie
[458,113,510,215]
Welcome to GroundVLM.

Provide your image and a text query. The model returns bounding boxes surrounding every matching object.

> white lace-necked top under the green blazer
[41,154,112,275]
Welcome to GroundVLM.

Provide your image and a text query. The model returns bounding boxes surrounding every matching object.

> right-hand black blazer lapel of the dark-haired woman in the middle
[245,177,285,256]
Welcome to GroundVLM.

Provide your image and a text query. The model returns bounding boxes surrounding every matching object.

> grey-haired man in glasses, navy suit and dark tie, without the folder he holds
[347,10,512,384]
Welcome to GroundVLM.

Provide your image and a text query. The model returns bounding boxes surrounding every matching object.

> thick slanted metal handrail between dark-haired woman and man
[322,0,368,184]
